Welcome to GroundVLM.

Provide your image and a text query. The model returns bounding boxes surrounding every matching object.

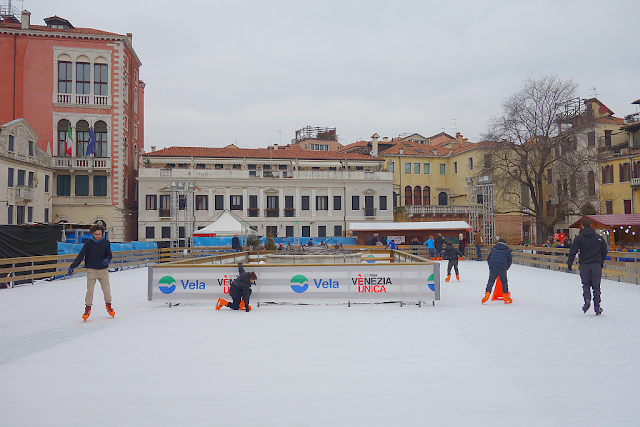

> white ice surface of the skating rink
[0,261,640,427]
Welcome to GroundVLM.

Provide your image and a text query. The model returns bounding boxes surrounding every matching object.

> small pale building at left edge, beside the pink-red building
[0,119,53,224]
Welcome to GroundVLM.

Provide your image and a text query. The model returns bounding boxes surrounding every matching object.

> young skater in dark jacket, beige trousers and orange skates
[68,224,116,320]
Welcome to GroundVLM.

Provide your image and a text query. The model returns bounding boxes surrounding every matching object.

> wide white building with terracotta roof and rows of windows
[138,145,393,243]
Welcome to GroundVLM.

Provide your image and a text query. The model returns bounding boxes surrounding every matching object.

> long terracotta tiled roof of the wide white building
[143,147,380,161]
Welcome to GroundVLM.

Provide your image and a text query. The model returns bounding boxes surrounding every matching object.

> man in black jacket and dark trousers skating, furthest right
[567,217,608,315]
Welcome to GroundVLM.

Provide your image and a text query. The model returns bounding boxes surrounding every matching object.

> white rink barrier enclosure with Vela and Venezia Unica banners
[148,250,440,307]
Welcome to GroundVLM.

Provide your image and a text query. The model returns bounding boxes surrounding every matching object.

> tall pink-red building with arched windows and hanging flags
[0,8,145,242]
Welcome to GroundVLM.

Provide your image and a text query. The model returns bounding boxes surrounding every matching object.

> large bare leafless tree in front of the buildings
[479,75,597,242]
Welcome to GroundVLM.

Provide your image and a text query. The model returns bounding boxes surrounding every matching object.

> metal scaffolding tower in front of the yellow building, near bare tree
[467,177,496,244]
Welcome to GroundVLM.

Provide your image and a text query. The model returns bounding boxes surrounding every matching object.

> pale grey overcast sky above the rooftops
[17,0,640,151]
